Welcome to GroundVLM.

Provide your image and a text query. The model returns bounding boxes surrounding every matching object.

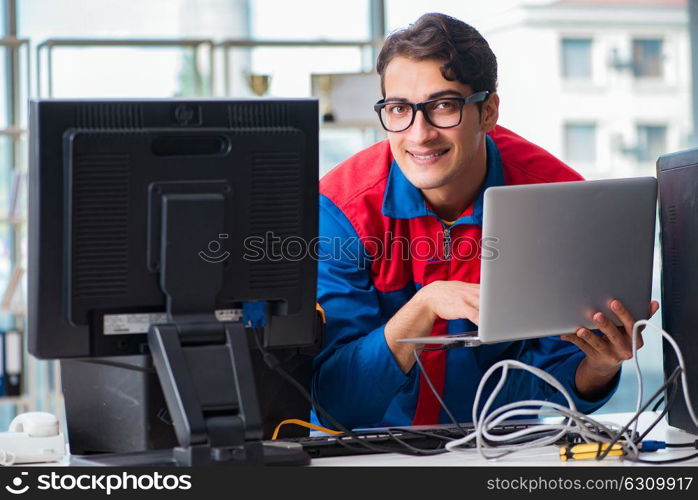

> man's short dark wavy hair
[376,13,497,97]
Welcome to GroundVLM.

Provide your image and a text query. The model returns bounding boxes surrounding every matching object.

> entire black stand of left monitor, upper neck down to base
[73,183,310,466]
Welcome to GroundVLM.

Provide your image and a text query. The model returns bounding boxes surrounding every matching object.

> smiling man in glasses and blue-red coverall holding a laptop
[313,14,658,427]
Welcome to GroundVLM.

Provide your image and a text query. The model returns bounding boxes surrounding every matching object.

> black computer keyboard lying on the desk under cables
[284,424,531,458]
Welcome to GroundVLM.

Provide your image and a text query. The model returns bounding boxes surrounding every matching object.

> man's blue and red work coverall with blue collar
[313,126,619,428]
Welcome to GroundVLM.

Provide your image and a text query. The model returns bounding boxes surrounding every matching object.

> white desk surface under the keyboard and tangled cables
[311,412,698,467]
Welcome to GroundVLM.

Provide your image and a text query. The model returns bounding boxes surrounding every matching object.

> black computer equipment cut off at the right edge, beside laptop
[657,149,698,433]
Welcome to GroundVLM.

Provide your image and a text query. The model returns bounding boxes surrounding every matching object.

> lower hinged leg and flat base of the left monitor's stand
[70,322,310,467]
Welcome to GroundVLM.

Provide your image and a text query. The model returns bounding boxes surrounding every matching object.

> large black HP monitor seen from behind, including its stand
[29,100,318,464]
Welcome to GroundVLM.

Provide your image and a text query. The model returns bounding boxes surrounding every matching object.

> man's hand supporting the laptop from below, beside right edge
[560,299,659,376]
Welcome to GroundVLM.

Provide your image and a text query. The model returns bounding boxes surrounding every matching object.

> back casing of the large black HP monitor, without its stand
[28,99,318,359]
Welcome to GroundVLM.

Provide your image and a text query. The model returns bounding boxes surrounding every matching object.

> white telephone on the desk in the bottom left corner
[0,411,65,465]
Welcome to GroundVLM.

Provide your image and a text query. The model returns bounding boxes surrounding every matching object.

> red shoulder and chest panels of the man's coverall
[320,126,582,292]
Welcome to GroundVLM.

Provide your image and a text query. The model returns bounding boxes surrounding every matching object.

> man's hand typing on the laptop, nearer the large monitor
[385,281,480,373]
